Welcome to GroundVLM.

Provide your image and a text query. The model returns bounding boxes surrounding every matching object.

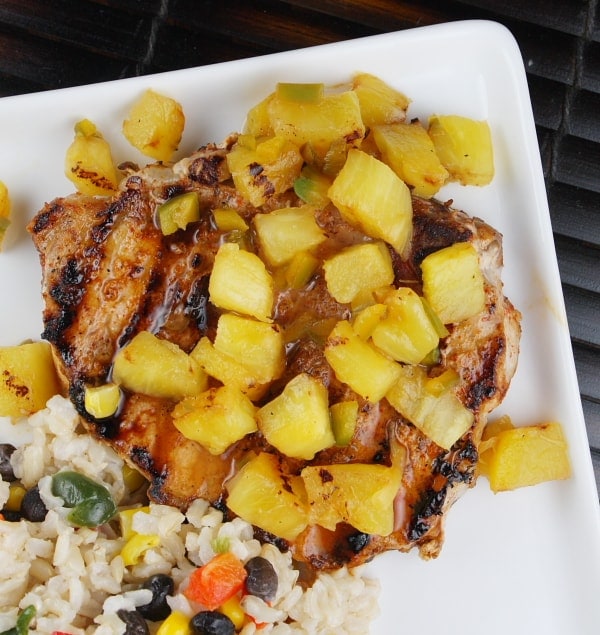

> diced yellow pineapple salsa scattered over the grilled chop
[0,73,568,556]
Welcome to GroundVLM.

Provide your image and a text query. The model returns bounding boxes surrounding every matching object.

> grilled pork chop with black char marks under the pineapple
[29,137,520,569]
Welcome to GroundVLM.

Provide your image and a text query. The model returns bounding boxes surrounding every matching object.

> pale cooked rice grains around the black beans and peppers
[0,396,379,635]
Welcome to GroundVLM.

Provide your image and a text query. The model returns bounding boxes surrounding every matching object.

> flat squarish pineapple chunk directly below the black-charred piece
[254,205,325,267]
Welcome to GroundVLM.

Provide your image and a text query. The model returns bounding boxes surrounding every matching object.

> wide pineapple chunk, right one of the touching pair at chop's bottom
[301,463,402,536]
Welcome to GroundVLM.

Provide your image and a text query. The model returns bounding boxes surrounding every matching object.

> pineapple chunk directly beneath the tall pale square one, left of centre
[214,313,285,384]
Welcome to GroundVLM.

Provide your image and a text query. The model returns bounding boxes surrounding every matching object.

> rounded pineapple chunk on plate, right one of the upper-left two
[123,89,185,161]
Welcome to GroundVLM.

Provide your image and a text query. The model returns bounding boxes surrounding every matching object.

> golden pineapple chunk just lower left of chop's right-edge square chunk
[371,287,439,364]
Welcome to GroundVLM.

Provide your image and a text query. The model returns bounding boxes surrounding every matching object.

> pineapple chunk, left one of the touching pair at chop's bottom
[226,452,308,540]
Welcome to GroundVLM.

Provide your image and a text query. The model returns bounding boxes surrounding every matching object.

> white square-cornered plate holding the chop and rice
[0,21,600,635]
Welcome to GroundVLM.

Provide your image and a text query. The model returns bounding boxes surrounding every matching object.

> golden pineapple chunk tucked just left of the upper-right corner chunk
[372,121,449,198]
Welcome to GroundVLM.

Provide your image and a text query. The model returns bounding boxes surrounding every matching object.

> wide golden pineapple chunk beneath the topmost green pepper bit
[268,91,365,158]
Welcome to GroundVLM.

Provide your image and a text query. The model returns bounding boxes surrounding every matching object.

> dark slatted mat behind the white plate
[0,0,600,494]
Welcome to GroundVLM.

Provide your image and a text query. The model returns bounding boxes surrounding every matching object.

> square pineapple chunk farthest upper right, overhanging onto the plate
[429,115,494,185]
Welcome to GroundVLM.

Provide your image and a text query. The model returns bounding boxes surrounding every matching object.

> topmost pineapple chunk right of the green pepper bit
[352,73,410,128]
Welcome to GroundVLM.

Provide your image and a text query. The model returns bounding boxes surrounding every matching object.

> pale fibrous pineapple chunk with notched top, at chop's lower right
[386,365,474,450]
